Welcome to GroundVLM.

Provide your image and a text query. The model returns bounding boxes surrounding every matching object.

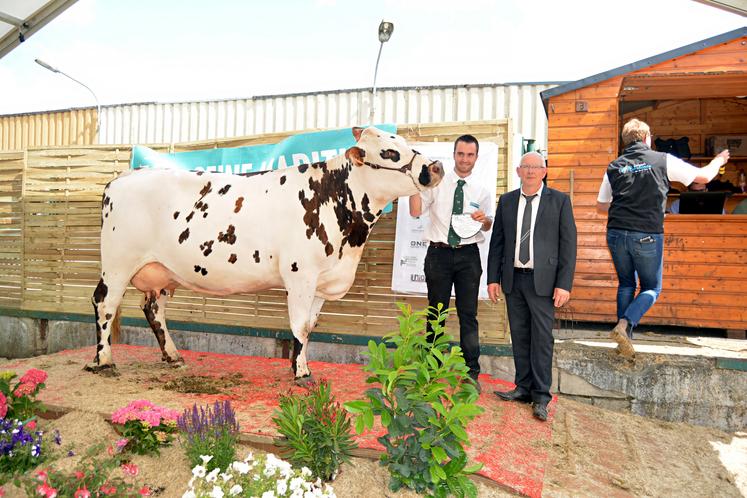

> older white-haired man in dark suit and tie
[487,152,576,421]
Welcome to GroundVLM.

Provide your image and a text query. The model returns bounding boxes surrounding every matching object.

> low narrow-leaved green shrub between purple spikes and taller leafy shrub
[272,380,356,481]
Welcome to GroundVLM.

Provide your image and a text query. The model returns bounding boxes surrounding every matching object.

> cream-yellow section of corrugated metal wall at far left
[0,107,96,151]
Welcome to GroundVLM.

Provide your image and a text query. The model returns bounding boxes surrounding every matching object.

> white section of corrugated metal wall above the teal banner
[99,83,555,148]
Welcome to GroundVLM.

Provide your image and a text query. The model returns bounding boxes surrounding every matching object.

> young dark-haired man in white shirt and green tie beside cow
[409,135,495,392]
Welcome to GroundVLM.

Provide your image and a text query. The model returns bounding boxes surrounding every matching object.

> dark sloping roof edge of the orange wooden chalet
[540,26,747,114]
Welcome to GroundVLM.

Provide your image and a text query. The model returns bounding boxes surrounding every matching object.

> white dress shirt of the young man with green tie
[420,171,495,245]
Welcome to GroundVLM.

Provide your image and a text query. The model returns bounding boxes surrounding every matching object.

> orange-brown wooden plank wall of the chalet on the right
[547,37,747,329]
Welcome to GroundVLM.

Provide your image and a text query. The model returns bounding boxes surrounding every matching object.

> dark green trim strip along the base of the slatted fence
[0,308,512,356]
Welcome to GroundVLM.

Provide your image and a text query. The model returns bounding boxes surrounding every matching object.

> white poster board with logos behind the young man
[392,142,498,304]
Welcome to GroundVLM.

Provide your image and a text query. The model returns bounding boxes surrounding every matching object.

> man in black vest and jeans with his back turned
[597,119,729,358]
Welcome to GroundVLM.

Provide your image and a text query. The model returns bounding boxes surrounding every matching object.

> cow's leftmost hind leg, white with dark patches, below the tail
[84,277,127,375]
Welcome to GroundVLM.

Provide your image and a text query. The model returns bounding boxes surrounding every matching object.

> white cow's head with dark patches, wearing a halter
[345,127,444,198]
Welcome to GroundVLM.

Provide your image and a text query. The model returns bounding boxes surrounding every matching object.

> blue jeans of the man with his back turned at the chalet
[607,228,664,337]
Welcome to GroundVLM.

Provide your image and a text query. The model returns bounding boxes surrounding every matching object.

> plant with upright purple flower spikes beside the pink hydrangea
[176,400,239,472]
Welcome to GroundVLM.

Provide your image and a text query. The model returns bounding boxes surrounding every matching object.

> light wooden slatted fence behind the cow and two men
[0,120,509,344]
